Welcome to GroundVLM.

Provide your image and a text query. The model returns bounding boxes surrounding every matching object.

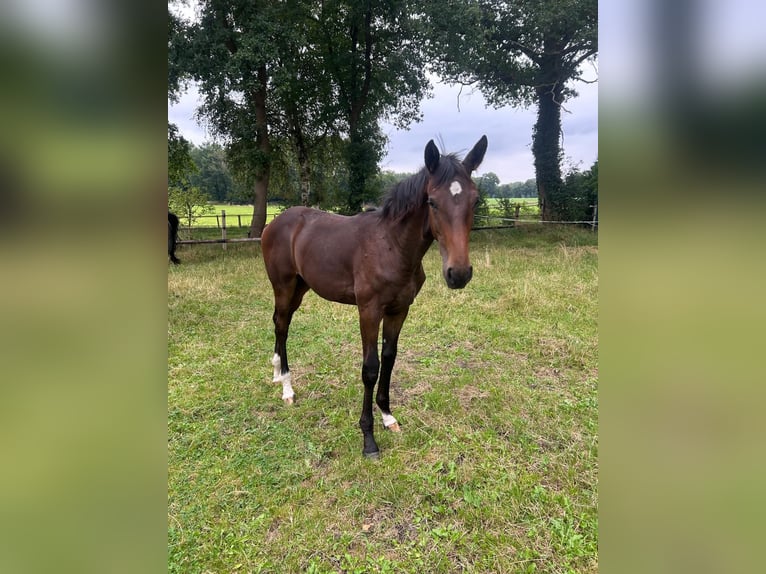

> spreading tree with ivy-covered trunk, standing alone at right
[427,0,598,220]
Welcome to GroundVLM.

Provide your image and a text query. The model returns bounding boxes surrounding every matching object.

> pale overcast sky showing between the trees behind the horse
[168,70,598,183]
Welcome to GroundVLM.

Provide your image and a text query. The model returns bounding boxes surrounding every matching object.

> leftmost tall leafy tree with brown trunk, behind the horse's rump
[174,0,298,237]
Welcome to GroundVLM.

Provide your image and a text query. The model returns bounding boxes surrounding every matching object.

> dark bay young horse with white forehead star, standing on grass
[261,136,487,459]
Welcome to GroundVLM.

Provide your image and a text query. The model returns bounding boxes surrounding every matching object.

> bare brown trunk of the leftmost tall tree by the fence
[248,66,271,237]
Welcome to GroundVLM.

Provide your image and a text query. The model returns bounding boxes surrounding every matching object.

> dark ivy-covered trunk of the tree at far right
[532,58,563,221]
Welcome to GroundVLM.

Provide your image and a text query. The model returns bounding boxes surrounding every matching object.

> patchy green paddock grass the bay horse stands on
[168,225,598,574]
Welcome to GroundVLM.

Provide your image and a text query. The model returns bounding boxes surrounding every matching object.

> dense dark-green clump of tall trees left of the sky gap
[169,0,436,218]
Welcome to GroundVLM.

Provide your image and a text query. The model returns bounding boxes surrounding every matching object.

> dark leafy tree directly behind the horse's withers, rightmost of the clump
[319,0,430,213]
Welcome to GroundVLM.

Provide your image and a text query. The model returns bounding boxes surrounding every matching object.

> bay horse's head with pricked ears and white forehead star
[425,136,487,289]
